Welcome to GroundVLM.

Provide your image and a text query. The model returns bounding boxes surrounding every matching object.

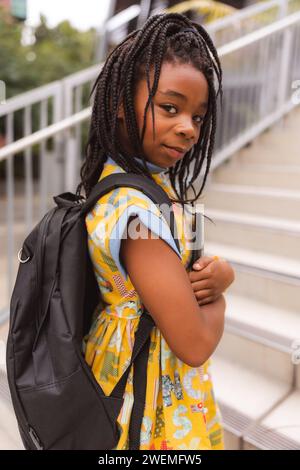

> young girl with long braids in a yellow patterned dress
[77,14,233,450]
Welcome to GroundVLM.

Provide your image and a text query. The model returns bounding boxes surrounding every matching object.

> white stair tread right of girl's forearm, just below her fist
[225,292,300,348]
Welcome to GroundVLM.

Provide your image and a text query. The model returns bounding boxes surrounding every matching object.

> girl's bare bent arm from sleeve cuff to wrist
[120,224,225,367]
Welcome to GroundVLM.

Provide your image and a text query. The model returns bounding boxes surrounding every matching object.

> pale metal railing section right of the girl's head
[212,12,300,170]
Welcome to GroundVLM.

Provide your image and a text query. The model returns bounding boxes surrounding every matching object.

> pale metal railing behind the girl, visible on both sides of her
[0,12,300,322]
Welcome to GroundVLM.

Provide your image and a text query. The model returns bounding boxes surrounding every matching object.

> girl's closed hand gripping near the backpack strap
[188,256,234,305]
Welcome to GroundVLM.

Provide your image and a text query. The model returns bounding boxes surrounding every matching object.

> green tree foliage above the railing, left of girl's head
[0,9,96,98]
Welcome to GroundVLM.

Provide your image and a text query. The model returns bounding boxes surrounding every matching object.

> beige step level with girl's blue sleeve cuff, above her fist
[205,209,300,260]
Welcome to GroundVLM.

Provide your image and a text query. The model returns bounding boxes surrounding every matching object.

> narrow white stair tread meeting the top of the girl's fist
[204,242,300,279]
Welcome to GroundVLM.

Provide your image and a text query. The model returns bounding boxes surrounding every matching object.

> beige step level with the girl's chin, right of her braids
[212,162,300,190]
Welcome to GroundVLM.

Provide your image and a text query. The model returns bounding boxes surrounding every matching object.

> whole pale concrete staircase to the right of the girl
[205,106,300,449]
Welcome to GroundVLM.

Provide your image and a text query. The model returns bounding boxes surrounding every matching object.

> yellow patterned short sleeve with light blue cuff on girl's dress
[89,188,181,279]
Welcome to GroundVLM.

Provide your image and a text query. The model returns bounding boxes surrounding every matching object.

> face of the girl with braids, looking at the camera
[119,62,208,168]
